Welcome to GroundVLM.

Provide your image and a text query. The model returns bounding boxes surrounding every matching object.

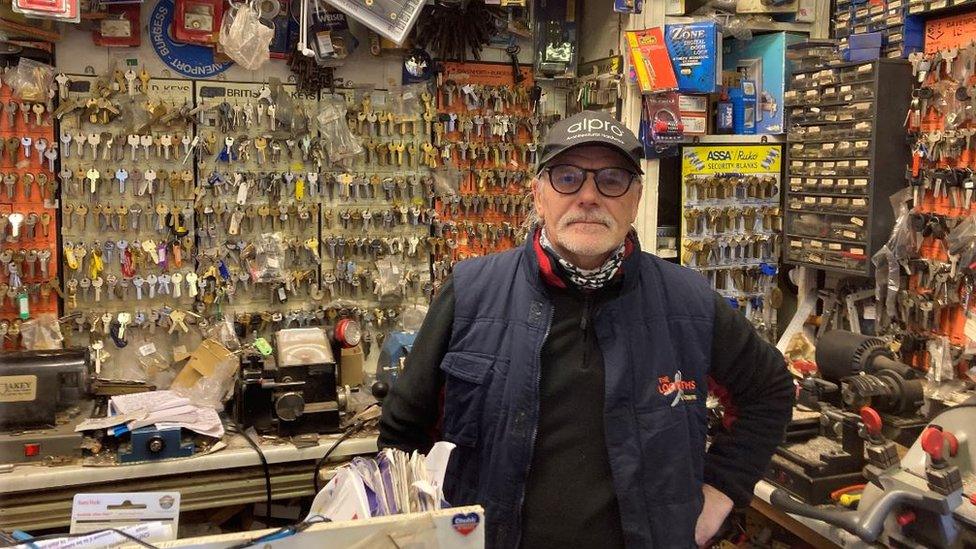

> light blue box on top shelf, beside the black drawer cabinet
[722,32,805,134]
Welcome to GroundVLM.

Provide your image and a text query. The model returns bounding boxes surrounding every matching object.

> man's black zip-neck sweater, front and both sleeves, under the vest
[379,280,793,548]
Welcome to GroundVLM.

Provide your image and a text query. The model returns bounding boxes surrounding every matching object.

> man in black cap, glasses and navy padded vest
[380,112,793,549]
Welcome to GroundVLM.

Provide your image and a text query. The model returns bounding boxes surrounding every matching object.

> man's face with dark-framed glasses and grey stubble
[532,145,643,268]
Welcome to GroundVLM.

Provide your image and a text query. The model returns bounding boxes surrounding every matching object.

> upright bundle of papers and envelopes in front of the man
[308,442,454,521]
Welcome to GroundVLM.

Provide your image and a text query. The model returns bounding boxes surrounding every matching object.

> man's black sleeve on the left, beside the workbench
[379,277,454,453]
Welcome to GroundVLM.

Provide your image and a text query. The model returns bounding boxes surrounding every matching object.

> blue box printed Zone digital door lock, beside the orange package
[664,22,722,93]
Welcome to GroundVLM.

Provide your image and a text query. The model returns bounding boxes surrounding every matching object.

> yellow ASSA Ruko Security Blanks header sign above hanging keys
[681,145,783,175]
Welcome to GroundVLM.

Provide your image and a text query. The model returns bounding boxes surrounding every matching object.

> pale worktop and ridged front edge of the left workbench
[0,433,377,531]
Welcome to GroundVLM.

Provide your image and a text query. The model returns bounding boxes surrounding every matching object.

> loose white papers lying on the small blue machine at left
[75,391,224,438]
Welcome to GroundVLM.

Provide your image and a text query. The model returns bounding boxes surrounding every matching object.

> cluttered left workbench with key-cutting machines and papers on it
[0,329,414,529]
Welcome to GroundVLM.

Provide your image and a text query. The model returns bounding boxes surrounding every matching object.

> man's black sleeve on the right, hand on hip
[705,294,795,506]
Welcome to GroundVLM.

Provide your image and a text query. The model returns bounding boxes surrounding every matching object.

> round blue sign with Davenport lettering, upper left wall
[149,0,233,78]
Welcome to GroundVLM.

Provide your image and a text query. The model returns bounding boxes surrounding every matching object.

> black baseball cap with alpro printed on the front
[539,111,644,173]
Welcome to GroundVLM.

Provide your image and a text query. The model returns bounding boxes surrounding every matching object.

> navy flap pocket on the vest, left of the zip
[441,352,495,447]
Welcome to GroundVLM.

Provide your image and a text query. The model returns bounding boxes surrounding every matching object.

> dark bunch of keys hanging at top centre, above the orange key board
[415,0,497,61]
